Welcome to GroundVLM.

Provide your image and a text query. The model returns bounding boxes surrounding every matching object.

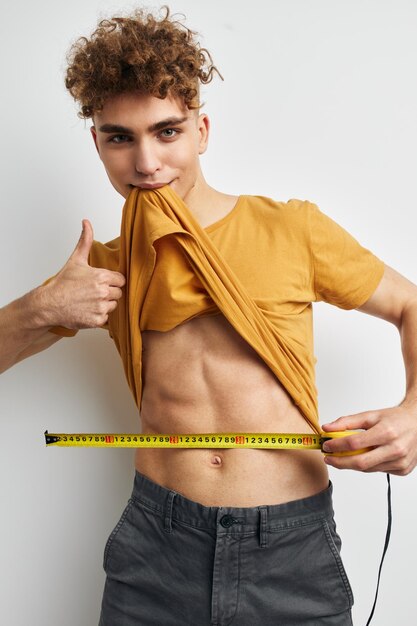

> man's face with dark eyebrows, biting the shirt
[91,93,209,199]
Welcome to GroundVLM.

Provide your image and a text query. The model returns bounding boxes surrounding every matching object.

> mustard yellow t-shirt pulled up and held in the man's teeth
[48,186,384,432]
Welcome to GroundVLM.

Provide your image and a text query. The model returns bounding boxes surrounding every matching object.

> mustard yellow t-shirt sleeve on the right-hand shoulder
[309,203,385,309]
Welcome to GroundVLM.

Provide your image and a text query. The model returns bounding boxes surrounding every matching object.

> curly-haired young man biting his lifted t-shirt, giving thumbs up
[0,6,417,626]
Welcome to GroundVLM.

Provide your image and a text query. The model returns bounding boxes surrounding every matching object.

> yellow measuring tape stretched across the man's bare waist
[45,430,365,454]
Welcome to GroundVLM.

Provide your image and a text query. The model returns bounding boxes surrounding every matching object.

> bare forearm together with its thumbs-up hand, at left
[0,220,125,373]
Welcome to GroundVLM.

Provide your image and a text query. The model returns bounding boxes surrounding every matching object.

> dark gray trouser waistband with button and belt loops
[132,471,333,547]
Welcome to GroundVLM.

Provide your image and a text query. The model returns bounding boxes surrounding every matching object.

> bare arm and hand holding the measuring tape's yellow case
[323,265,417,476]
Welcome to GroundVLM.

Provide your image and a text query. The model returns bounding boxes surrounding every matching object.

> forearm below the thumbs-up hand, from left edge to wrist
[0,287,51,373]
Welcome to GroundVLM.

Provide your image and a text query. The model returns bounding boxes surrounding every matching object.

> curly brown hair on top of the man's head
[65,6,223,119]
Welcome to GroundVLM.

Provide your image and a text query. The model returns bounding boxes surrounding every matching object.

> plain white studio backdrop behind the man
[0,0,417,626]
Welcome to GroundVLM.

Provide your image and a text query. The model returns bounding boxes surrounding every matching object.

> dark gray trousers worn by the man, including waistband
[99,472,353,626]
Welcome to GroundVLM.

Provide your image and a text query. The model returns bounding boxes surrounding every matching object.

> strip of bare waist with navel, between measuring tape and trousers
[135,449,329,507]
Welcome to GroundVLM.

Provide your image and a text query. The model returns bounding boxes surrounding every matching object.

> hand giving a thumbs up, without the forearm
[43,220,126,329]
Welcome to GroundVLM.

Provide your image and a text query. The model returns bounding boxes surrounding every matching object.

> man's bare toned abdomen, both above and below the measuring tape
[135,314,329,507]
